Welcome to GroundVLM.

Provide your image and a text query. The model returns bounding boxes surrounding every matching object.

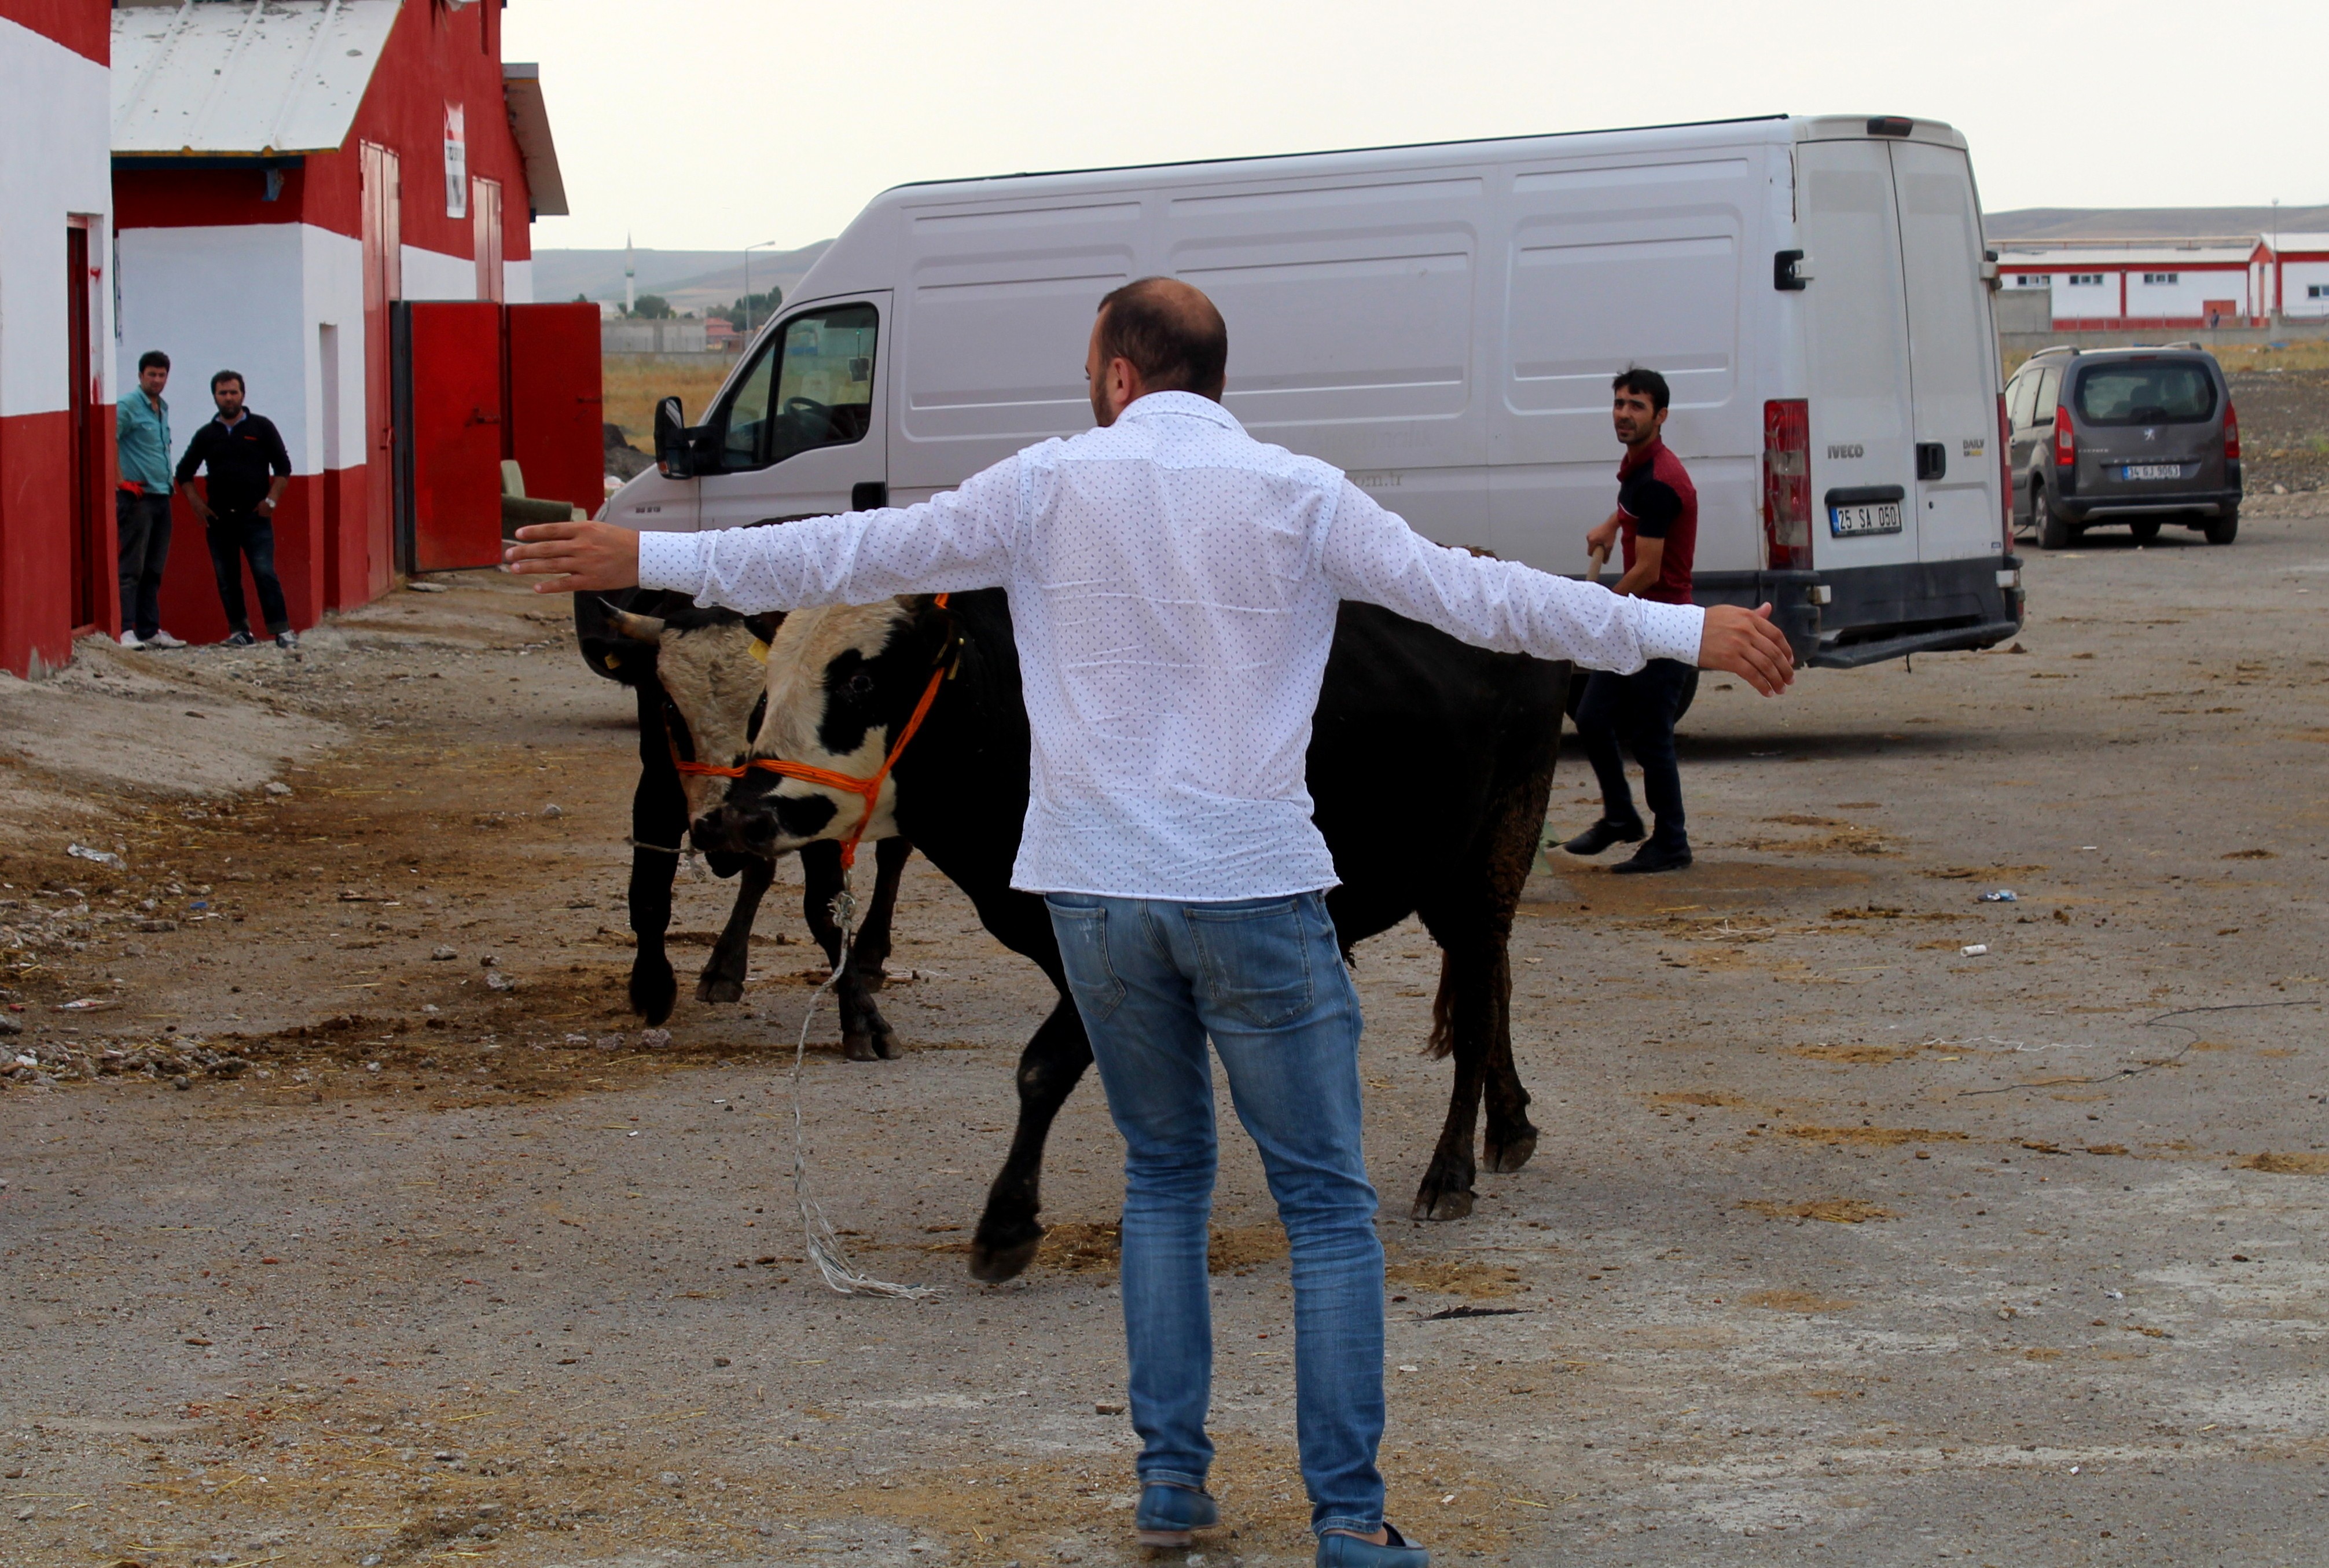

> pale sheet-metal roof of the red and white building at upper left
[112,0,401,159]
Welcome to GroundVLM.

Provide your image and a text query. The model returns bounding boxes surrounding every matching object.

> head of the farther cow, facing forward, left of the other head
[608,606,785,820]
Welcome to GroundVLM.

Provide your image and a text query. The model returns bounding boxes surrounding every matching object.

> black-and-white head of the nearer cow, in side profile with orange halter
[694,598,932,855]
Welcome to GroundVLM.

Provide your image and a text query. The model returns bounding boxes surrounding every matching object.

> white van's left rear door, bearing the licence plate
[1796,140,1919,571]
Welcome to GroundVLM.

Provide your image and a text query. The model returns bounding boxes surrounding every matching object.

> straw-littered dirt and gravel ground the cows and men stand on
[0,496,2329,1568]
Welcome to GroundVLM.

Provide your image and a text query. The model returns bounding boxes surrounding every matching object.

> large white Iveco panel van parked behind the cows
[585,116,2022,666]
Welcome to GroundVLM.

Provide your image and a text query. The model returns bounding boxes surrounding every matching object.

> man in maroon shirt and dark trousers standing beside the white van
[1560,368,1698,871]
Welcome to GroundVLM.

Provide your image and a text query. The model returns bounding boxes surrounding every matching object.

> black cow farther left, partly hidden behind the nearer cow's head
[589,598,913,1060]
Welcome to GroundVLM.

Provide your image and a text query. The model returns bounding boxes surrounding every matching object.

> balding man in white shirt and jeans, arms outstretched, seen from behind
[508,277,1793,1568]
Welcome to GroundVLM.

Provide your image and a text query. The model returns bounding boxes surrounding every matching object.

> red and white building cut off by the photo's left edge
[0,0,121,675]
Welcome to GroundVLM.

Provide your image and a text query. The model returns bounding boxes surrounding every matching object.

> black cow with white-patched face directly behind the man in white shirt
[696,589,1570,1279]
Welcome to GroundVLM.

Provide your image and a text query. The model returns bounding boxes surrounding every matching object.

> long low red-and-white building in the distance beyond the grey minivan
[1999,238,2268,331]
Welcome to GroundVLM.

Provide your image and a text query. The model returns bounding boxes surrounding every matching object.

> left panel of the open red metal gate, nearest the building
[396,300,503,571]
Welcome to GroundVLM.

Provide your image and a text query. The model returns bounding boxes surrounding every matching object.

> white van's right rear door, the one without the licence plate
[1891,142,2003,561]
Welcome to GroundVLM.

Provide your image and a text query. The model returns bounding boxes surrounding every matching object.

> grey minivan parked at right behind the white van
[2005,343,2240,550]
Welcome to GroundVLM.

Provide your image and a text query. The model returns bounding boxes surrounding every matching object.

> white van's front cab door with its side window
[696,291,890,529]
